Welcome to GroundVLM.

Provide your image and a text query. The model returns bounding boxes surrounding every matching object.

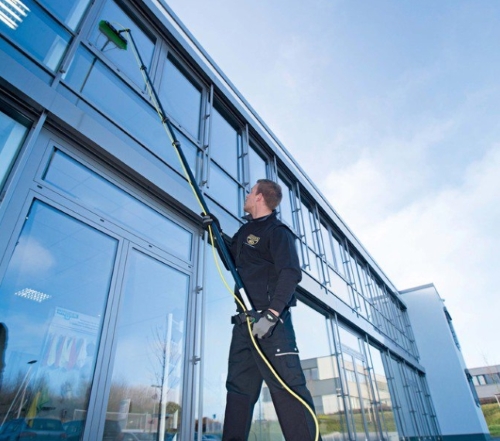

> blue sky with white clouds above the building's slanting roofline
[168,0,500,367]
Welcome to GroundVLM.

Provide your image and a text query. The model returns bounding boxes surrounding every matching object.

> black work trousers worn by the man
[222,311,316,441]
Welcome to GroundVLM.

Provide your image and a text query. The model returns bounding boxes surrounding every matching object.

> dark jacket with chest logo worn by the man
[229,212,302,314]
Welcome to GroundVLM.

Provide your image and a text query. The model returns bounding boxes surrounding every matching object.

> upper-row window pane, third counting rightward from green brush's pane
[210,108,240,178]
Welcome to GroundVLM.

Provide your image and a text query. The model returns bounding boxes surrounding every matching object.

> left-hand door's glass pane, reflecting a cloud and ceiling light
[0,201,117,431]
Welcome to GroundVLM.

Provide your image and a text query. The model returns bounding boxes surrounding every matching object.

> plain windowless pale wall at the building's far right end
[401,285,489,440]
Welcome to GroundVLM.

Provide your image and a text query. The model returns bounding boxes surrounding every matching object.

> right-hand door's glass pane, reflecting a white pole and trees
[103,250,189,441]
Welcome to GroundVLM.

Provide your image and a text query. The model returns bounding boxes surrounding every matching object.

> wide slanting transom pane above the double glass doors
[44,151,192,260]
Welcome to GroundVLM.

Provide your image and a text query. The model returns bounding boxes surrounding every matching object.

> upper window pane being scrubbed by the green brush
[90,1,155,89]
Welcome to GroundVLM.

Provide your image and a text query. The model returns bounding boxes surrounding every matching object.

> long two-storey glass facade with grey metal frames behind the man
[0,0,450,441]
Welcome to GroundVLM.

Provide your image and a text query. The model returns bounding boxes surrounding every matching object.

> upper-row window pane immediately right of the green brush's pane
[159,57,201,139]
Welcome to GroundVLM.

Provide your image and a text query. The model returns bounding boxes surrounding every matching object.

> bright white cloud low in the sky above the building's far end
[330,145,500,366]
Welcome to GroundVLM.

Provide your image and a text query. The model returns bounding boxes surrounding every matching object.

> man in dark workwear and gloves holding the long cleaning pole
[204,179,316,441]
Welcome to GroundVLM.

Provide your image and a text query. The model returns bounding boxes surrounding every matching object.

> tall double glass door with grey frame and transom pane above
[0,133,196,441]
